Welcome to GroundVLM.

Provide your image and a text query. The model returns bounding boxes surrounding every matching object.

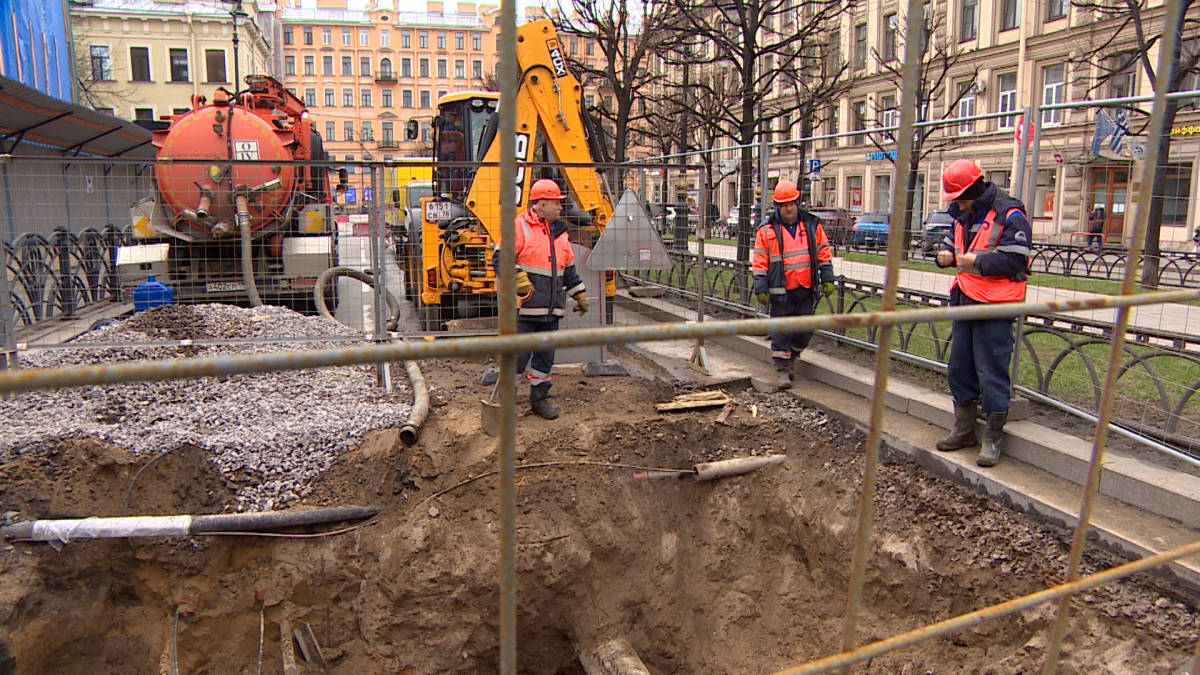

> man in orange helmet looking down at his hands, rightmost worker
[937,160,1031,466]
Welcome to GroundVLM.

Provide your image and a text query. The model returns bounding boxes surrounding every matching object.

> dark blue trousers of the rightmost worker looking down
[947,318,1013,414]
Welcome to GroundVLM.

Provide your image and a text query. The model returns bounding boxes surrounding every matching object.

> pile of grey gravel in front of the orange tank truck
[0,305,412,510]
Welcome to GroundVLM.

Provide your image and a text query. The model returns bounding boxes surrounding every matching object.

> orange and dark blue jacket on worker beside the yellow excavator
[492,210,587,318]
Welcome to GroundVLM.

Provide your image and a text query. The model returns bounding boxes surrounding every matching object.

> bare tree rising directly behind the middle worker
[662,0,852,261]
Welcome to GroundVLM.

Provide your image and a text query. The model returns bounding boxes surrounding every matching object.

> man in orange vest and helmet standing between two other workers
[750,180,834,389]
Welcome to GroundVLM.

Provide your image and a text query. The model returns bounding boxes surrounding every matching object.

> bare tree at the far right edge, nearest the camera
[1070,0,1200,288]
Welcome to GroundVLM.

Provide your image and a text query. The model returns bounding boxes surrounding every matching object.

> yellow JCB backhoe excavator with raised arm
[401,20,616,330]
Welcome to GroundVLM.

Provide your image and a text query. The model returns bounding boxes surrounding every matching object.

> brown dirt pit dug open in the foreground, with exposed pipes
[0,355,1200,675]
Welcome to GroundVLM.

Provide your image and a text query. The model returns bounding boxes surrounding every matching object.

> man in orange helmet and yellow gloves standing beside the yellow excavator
[492,179,588,419]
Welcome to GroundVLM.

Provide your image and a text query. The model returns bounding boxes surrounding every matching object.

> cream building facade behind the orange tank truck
[71,0,275,123]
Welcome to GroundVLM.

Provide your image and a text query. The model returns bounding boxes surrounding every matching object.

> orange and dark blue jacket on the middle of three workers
[750,207,833,298]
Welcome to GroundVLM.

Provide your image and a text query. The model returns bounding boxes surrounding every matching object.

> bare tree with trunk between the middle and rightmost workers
[868,2,979,261]
